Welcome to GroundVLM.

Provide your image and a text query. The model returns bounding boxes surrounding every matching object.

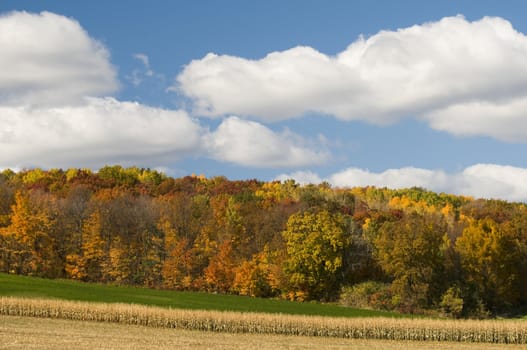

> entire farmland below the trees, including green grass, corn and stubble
[0,274,527,350]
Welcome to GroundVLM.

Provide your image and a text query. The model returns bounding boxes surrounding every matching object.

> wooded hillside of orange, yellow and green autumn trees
[0,166,527,317]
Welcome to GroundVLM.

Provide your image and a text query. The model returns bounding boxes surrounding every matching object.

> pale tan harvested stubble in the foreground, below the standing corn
[0,316,524,350]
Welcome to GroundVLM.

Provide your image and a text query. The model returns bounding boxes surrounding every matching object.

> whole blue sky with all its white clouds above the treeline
[0,0,527,201]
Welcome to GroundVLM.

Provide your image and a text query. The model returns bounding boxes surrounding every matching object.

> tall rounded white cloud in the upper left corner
[0,12,118,106]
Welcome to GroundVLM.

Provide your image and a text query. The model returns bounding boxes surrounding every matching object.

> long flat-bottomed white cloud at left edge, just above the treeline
[0,98,204,168]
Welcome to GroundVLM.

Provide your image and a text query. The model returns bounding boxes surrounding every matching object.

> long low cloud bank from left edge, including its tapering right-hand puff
[0,98,327,169]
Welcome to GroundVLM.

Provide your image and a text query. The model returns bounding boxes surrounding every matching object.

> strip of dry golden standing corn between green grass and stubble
[0,297,527,344]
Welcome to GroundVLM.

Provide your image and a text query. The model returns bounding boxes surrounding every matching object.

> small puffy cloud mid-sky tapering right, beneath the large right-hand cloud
[205,117,329,168]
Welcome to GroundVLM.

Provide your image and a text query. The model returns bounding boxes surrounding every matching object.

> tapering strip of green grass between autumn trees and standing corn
[0,273,400,317]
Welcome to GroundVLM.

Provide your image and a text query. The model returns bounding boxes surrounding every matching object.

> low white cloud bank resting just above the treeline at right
[277,164,527,202]
